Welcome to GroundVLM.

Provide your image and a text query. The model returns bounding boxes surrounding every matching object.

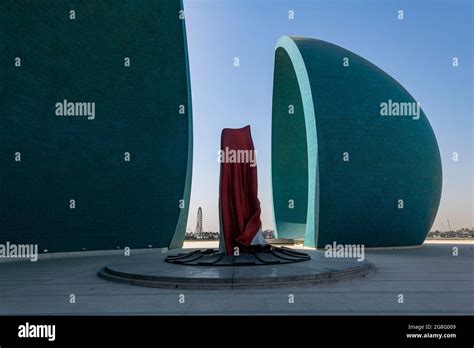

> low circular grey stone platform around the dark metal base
[98,250,375,289]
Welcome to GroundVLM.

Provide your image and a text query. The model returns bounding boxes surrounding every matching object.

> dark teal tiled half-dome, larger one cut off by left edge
[0,0,193,253]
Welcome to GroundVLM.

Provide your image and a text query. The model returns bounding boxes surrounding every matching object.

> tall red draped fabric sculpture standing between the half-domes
[219,126,262,255]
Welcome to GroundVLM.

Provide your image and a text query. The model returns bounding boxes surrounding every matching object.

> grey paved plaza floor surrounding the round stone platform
[0,241,474,315]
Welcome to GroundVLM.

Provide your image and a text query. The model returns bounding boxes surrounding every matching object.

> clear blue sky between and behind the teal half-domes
[184,0,474,231]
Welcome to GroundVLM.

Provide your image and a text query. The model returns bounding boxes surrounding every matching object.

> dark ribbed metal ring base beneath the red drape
[165,246,311,266]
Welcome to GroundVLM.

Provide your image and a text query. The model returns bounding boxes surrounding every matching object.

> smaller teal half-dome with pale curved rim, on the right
[272,36,442,248]
